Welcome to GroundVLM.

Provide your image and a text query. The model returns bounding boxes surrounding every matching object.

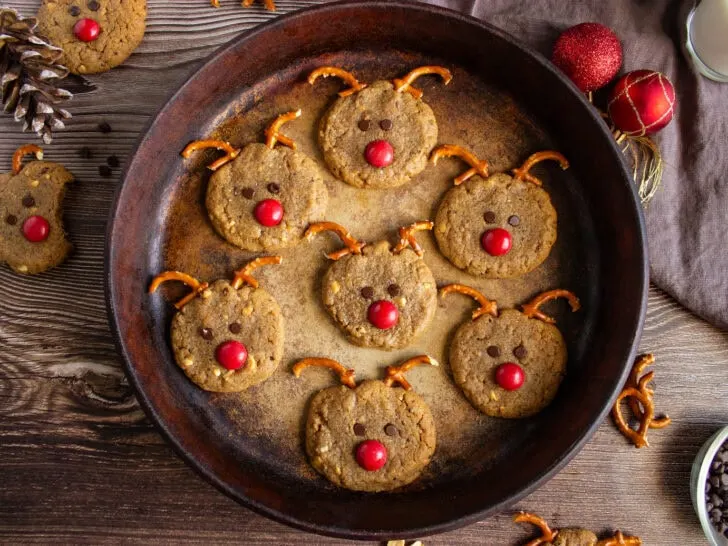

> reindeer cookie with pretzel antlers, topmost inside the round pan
[308,66,452,188]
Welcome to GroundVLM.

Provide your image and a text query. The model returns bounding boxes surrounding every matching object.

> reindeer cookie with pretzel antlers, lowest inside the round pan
[293,355,437,492]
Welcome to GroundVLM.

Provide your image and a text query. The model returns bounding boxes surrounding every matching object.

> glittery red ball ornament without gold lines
[551,23,622,93]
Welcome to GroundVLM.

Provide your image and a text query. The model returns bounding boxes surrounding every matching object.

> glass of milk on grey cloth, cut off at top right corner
[685,0,728,82]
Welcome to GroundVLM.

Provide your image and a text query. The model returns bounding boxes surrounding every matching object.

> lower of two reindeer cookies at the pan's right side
[441,284,579,419]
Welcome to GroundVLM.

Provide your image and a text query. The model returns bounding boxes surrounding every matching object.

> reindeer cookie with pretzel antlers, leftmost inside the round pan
[149,256,283,392]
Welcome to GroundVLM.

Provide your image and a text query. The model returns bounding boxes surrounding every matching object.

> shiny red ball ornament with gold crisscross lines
[607,70,675,136]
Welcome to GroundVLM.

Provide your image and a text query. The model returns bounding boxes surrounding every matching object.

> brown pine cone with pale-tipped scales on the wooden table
[0,8,73,144]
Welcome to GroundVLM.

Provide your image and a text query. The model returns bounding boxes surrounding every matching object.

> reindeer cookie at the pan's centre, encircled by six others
[306,222,437,351]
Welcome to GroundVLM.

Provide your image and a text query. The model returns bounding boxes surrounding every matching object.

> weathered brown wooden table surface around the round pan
[0,0,728,546]
